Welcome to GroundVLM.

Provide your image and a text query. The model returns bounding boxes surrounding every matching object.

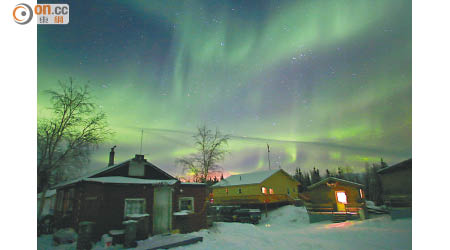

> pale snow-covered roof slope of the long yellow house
[213,169,281,187]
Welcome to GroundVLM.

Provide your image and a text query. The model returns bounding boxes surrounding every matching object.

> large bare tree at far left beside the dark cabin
[37,78,112,218]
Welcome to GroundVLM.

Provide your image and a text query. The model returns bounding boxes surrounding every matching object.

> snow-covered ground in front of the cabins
[38,206,412,250]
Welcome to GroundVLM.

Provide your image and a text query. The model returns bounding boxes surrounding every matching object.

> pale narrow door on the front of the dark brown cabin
[153,187,172,234]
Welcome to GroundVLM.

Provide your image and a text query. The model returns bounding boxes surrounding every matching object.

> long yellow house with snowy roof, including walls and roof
[212,169,300,205]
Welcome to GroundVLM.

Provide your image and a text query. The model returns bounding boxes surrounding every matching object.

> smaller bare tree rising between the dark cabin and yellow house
[176,125,230,182]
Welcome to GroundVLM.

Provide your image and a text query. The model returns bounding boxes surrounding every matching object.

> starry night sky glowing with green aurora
[38,0,412,179]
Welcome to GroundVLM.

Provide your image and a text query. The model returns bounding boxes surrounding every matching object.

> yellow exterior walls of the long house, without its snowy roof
[213,171,300,205]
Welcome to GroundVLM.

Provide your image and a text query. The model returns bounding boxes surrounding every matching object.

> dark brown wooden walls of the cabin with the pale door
[55,182,208,238]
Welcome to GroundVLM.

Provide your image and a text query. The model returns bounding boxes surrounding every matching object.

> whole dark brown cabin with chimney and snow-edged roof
[55,155,208,237]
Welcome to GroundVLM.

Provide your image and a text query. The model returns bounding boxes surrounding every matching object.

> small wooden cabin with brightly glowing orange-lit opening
[302,177,367,222]
